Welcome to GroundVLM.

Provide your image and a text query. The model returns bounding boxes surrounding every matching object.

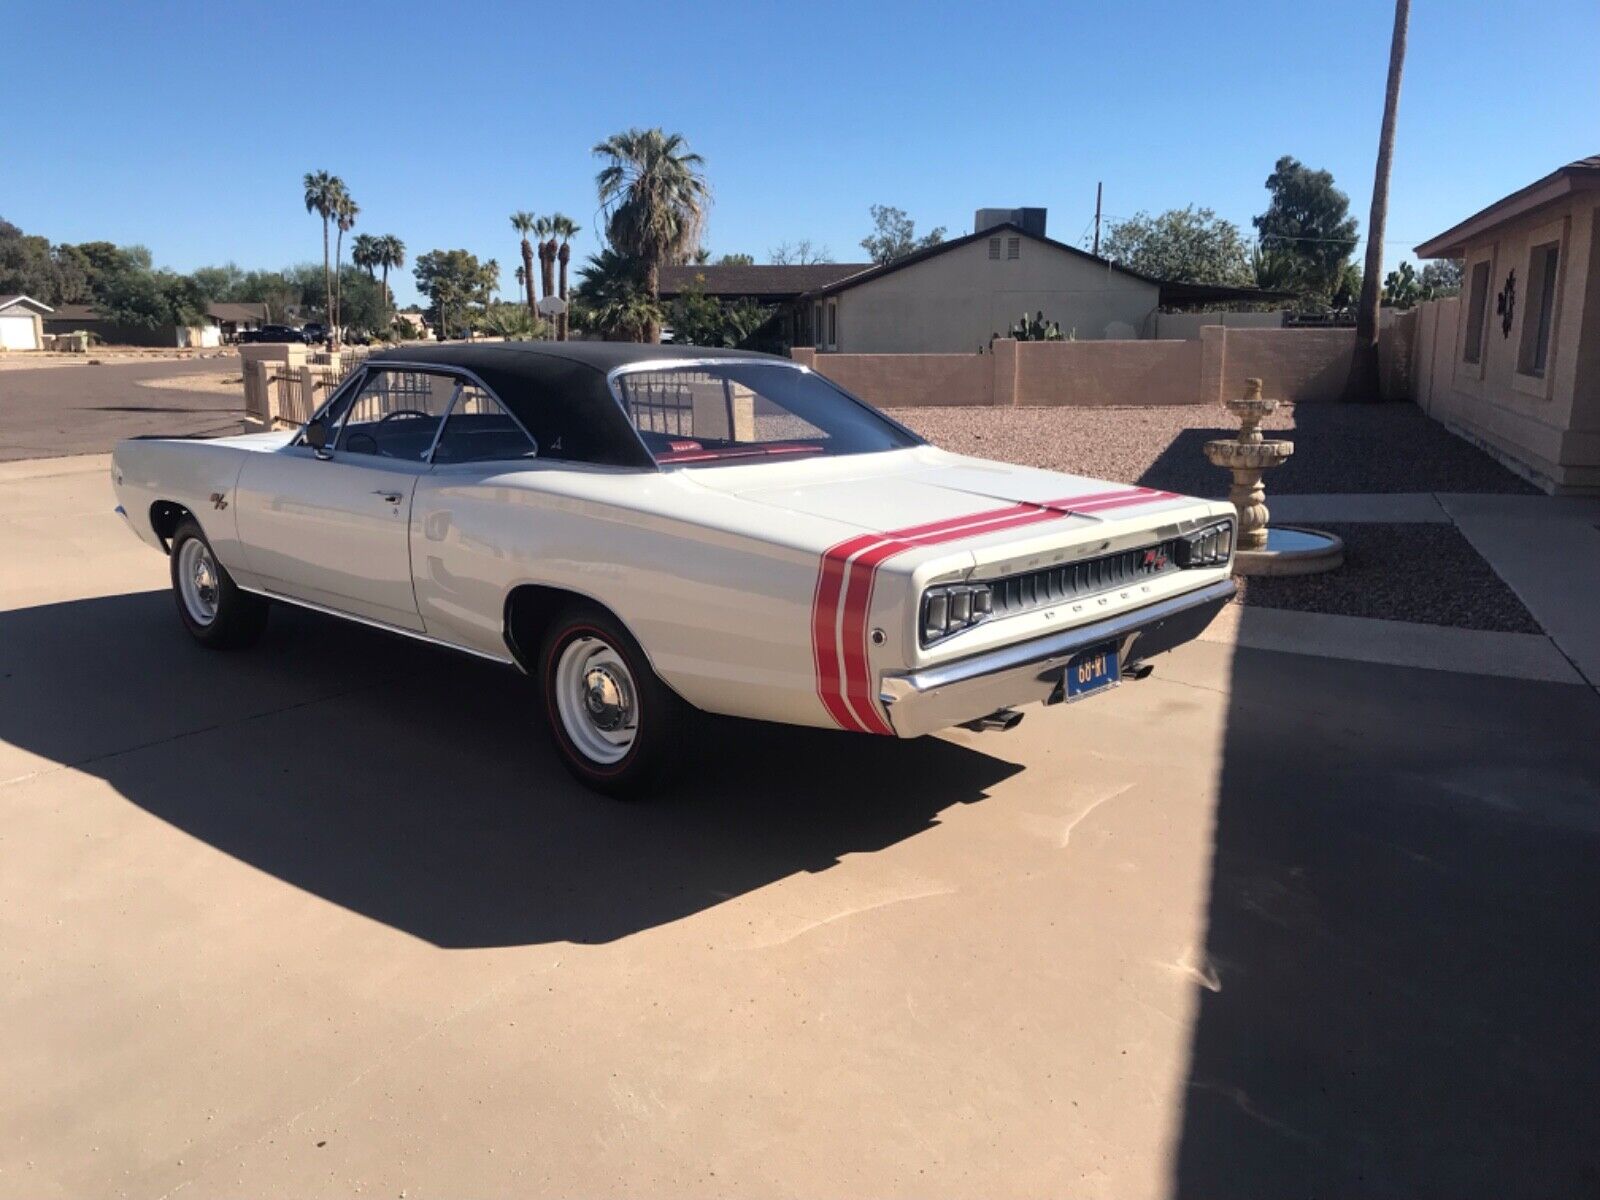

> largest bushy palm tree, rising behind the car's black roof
[594,130,710,342]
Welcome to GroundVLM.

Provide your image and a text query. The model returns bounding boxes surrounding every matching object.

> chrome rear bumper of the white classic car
[878,579,1235,738]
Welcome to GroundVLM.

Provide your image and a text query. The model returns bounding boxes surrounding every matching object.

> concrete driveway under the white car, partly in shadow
[9,459,1600,1200]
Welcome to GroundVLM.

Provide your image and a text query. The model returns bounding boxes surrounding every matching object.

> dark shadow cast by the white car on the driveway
[0,592,1021,947]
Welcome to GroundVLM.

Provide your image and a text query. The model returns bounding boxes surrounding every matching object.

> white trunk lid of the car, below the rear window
[693,448,1192,533]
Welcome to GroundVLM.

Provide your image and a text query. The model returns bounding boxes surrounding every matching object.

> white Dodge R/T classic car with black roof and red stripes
[112,342,1234,795]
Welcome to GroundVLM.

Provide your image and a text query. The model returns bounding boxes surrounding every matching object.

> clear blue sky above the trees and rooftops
[0,0,1600,302]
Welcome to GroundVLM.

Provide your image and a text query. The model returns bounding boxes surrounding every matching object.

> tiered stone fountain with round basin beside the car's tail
[1205,379,1344,574]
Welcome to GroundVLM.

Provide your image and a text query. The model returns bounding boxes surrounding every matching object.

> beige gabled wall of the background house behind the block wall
[837,234,1158,354]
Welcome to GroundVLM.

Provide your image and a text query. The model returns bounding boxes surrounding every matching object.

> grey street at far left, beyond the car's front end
[0,352,245,462]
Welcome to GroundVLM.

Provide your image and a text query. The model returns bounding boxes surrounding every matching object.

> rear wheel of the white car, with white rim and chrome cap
[539,605,690,798]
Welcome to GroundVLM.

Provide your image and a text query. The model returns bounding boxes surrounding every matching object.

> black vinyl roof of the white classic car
[366,342,789,469]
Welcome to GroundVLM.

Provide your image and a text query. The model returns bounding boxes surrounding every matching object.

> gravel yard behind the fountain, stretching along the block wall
[891,402,1536,504]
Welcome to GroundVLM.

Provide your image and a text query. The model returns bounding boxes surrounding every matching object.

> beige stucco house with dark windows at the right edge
[1411,155,1600,494]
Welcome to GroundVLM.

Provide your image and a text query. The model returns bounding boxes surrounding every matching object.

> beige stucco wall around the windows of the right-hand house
[1411,192,1600,493]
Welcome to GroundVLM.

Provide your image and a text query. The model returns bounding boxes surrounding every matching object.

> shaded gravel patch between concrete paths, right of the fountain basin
[1235,522,1544,634]
